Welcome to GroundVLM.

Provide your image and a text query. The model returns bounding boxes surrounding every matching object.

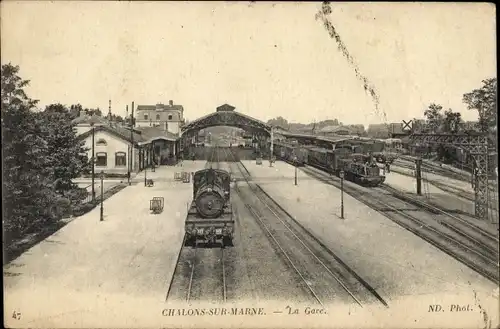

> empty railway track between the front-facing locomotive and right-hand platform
[225,147,388,307]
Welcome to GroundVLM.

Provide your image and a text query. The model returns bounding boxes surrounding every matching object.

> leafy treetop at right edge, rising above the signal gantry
[462,78,497,132]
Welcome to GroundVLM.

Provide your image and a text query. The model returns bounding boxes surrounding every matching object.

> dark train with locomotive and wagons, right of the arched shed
[273,142,385,187]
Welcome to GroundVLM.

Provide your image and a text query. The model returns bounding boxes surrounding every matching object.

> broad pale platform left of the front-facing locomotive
[4,161,205,328]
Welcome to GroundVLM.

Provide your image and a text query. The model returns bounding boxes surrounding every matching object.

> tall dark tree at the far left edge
[1,63,54,243]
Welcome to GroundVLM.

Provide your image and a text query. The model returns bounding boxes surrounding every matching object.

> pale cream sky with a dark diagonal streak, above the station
[0,1,496,125]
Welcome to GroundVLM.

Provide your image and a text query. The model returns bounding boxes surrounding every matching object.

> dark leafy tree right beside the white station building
[39,104,89,197]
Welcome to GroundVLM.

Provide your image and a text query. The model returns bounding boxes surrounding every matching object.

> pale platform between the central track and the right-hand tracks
[243,161,498,312]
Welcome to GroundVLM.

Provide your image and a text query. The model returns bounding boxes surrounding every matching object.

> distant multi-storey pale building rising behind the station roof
[134,100,185,136]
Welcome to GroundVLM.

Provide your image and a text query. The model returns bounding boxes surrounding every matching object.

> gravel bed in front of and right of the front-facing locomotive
[169,174,308,303]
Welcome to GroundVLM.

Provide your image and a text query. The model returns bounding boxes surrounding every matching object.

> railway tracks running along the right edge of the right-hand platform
[302,166,499,283]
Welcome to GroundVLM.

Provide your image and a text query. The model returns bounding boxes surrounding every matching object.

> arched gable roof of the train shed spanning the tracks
[181,104,271,135]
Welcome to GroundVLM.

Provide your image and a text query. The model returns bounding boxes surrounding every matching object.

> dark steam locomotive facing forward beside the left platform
[184,168,234,246]
